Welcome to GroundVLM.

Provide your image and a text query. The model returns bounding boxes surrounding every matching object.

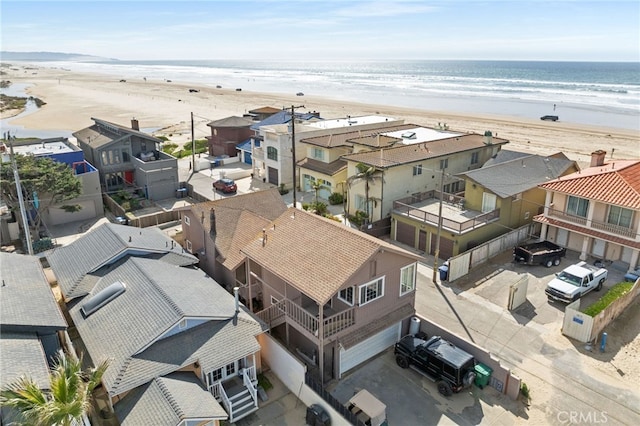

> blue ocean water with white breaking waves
[5,60,640,131]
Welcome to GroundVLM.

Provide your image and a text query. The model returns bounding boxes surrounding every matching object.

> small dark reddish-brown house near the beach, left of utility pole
[207,117,255,157]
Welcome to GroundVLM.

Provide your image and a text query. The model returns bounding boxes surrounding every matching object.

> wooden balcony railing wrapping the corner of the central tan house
[256,299,356,338]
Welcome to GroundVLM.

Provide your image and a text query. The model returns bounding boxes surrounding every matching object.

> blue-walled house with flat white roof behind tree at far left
[0,138,104,230]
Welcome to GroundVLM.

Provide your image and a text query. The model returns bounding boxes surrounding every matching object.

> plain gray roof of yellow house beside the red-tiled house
[459,155,575,198]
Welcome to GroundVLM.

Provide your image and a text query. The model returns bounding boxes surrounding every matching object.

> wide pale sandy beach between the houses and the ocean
[2,64,640,167]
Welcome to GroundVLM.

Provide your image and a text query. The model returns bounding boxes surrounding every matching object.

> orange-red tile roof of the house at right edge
[539,160,640,209]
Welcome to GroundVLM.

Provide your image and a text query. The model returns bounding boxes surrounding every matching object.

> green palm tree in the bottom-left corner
[0,350,109,426]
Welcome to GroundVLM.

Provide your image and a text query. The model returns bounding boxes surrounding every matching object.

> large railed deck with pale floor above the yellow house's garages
[393,191,500,234]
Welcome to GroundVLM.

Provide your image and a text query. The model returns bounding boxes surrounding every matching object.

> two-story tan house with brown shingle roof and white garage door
[241,207,419,381]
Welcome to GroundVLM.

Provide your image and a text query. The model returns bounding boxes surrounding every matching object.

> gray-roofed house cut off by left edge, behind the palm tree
[0,252,68,424]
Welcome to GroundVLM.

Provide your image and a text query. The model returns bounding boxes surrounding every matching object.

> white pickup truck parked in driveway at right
[545,262,608,303]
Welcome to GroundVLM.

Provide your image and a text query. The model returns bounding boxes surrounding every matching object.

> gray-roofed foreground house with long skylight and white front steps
[69,257,266,425]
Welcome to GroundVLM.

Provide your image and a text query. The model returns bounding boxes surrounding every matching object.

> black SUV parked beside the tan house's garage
[393,335,476,396]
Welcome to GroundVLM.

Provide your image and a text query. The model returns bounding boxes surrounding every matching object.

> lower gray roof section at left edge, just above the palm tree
[0,331,50,389]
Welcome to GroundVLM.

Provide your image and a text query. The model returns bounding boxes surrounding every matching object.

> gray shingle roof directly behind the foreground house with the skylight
[47,223,198,300]
